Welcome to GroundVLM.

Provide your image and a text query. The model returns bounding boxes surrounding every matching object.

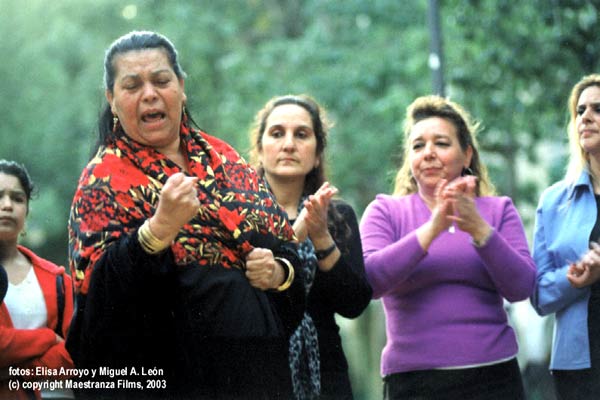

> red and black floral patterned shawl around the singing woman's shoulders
[69,124,294,294]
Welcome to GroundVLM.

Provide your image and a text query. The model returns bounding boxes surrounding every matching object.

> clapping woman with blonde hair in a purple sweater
[360,96,536,400]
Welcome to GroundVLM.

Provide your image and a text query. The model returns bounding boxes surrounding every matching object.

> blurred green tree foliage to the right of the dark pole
[443,0,599,220]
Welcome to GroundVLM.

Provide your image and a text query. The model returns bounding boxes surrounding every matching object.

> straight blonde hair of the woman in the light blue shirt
[565,74,600,183]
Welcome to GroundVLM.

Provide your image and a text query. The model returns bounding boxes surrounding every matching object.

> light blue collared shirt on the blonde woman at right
[531,171,597,370]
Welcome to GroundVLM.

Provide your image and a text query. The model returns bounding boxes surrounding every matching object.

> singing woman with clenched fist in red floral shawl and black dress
[67,32,305,399]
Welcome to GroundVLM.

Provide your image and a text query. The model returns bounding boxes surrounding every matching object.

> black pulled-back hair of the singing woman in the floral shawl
[92,31,193,155]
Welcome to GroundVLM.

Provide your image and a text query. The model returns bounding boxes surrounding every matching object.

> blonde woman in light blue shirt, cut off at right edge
[532,74,600,400]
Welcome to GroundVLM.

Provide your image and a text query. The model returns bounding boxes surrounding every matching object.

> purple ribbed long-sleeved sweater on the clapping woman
[360,194,536,376]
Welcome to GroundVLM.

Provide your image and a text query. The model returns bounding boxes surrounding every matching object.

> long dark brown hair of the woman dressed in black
[250,94,350,239]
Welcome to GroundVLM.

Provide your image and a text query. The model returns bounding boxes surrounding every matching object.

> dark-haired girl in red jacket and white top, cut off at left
[0,160,73,399]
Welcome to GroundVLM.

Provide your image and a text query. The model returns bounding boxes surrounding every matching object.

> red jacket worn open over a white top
[0,246,74,399]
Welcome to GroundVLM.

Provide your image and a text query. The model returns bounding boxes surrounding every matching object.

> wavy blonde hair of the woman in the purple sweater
[394,95,495,196]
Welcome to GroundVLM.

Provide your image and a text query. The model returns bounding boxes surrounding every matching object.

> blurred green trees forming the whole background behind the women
[0,0,600,399]
